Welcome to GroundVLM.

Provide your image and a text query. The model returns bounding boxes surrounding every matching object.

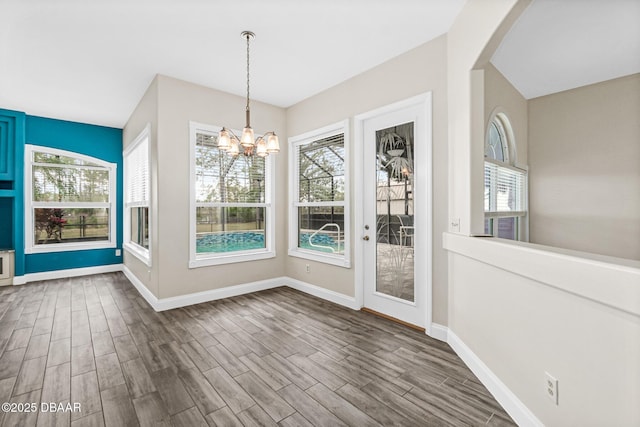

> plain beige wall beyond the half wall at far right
[529,74,640,260]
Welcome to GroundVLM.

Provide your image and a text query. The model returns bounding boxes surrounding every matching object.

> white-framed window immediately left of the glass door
[289,121,350,267]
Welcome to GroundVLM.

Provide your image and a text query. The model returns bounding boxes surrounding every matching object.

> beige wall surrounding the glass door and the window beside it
[286,36,448,324]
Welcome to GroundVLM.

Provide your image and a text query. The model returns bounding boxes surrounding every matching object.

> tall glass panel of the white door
[376,122,415,302]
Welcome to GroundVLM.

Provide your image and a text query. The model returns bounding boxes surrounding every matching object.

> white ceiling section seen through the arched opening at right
[491,0,640,99]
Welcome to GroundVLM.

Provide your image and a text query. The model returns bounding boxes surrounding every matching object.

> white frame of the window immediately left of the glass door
[288,120,351,268]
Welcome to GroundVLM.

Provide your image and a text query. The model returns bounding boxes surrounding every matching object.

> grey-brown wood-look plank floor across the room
[0,273,514,427]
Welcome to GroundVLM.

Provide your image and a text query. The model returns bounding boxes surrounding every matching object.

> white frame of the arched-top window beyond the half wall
[484,112,529,241]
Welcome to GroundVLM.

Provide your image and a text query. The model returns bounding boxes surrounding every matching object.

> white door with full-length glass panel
[362,98,430,327]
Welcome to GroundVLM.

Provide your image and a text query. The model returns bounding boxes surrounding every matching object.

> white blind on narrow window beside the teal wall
[125,138,149,206]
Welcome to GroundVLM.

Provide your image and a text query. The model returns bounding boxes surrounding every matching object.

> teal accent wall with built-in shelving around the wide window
[0,109,123,276]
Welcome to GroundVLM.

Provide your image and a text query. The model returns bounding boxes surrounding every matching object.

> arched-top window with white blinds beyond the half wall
[484,113,527,240]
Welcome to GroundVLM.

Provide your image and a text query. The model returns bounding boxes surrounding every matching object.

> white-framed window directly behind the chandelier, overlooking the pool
[189,123,275,267]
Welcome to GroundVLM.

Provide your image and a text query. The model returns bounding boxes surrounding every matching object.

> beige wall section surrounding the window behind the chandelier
[151,75,288,298]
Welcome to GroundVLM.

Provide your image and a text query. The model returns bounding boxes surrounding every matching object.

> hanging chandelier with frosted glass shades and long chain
[218,31,280,157]
